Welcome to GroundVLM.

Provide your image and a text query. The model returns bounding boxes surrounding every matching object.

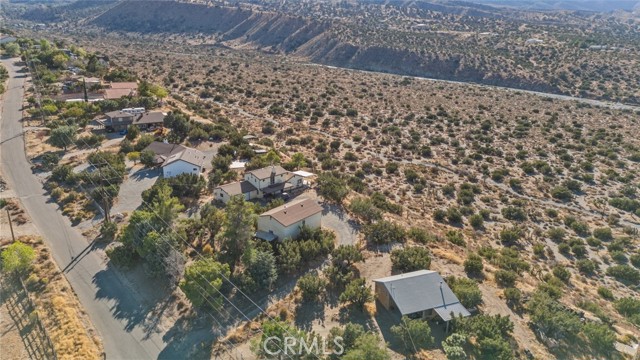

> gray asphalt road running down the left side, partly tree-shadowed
[0,59,165,359]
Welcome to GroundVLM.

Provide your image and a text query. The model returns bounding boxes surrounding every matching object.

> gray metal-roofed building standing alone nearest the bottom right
[373,270,470,322]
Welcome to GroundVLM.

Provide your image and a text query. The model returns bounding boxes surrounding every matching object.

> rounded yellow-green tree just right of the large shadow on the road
[180,258,231,307]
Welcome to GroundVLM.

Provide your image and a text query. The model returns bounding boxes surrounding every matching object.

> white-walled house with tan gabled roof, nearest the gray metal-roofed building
[256,198,322,241]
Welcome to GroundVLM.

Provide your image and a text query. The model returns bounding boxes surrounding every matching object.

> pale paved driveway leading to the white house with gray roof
[111,165,160,215]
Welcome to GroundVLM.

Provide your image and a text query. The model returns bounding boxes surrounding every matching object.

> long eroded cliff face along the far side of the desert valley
[91,0,557,92]
